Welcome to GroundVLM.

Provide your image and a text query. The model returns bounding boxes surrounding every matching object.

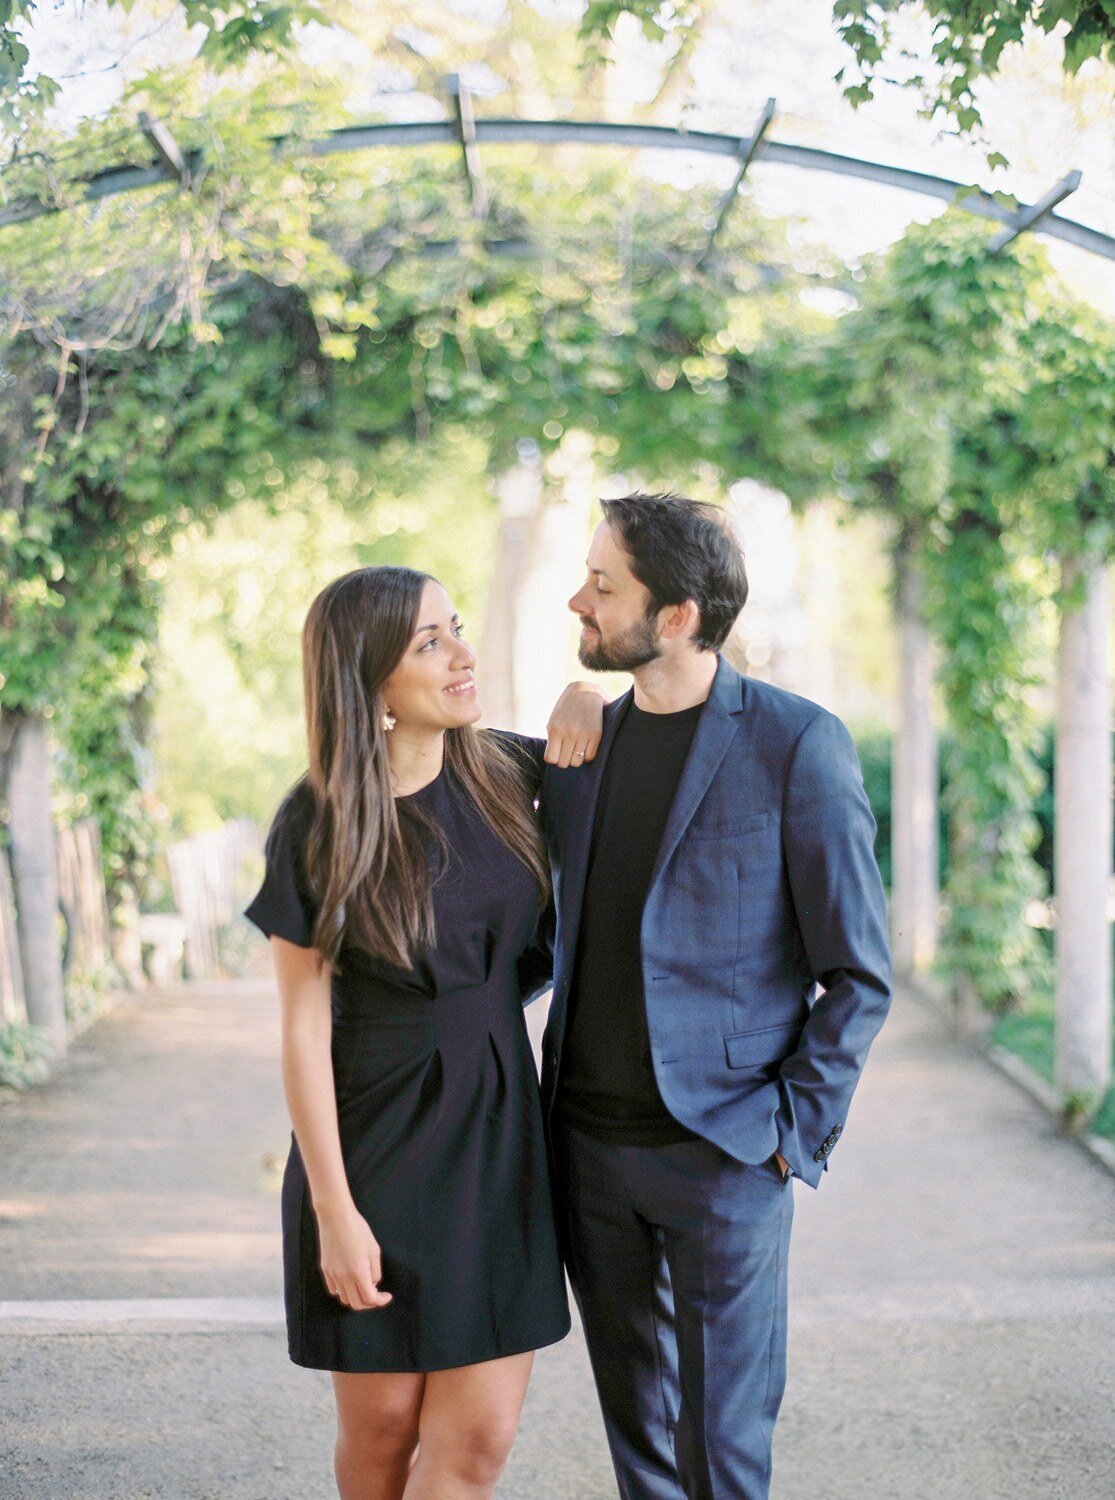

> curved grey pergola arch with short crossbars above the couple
[0,88,1115,270]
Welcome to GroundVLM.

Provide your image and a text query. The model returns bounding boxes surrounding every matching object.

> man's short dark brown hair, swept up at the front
[600,491,747,651]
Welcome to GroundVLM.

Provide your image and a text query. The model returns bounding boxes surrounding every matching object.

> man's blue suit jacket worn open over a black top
[540,657,890,1187]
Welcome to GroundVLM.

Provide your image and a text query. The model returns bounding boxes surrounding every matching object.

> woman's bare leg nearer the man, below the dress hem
[404,1353,534,1500]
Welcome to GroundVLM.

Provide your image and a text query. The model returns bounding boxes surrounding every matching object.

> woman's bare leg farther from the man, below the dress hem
[333,1371,429,1500]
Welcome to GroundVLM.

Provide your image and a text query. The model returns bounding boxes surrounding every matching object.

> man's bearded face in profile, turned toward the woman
[569,521,662,672]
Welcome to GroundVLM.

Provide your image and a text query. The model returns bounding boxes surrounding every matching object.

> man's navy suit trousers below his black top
[554,1124,794,1500]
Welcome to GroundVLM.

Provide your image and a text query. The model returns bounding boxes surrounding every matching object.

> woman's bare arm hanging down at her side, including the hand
[272,938,392,1308]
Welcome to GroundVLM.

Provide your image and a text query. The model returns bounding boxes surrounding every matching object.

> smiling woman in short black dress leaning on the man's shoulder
[248,567,600,1500]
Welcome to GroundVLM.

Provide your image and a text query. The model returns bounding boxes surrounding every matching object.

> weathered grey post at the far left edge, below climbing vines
[5,711,66,1055]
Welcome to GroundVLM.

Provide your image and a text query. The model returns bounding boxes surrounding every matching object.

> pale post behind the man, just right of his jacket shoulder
[890,546,939,977]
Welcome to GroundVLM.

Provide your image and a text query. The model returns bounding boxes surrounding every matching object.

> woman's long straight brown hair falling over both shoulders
[302,567,549,969]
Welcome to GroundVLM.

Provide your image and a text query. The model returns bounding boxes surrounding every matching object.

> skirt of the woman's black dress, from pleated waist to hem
[282,978,569,1371]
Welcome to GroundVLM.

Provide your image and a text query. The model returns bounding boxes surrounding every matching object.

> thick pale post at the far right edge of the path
[1053,560,1112,1107]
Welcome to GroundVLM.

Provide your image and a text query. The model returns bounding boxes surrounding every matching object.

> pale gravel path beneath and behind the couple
[0,980,1115,1500]
